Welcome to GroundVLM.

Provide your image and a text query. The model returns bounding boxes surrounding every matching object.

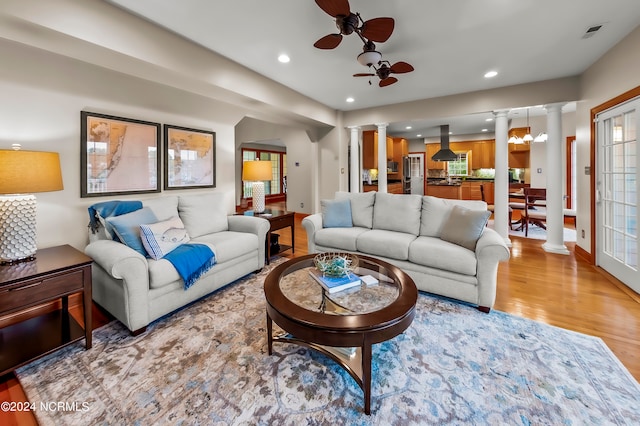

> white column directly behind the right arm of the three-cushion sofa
[493,110,511,247]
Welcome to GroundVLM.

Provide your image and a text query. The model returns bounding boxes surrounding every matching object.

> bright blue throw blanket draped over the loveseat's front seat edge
[164,244,216,290]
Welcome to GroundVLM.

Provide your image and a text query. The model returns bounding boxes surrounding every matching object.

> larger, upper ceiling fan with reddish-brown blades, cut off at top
[313,0,395,49]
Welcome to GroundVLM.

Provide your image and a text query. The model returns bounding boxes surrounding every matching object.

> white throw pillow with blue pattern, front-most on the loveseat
[140,216,189,260]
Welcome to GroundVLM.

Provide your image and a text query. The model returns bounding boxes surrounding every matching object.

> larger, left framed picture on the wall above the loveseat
[80,111,161,198]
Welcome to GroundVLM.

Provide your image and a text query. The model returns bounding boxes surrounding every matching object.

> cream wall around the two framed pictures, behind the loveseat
[0,39,242,249]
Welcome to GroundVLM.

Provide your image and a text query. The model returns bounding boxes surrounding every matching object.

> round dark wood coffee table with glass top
[264,254,418,414]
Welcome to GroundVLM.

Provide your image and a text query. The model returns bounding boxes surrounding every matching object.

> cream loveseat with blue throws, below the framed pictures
[85,193,269,334]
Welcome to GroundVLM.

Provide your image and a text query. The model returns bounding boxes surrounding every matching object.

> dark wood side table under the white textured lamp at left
[0,245,93,376]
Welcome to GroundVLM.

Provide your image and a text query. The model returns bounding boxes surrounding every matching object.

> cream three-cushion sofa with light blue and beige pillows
[302,192,509,312]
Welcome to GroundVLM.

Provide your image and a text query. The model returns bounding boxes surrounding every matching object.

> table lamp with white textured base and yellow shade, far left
[0,145,64,264]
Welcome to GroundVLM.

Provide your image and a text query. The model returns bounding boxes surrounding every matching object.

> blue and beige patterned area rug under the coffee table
[18,262,640,426]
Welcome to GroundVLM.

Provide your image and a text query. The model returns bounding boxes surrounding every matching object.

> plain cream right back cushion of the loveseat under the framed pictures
[178,192,229,238]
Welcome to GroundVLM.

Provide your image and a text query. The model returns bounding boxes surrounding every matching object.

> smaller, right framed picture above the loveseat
[164,124,216,189]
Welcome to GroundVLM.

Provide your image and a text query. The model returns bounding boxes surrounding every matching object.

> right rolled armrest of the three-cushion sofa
[476,228,510,308]
